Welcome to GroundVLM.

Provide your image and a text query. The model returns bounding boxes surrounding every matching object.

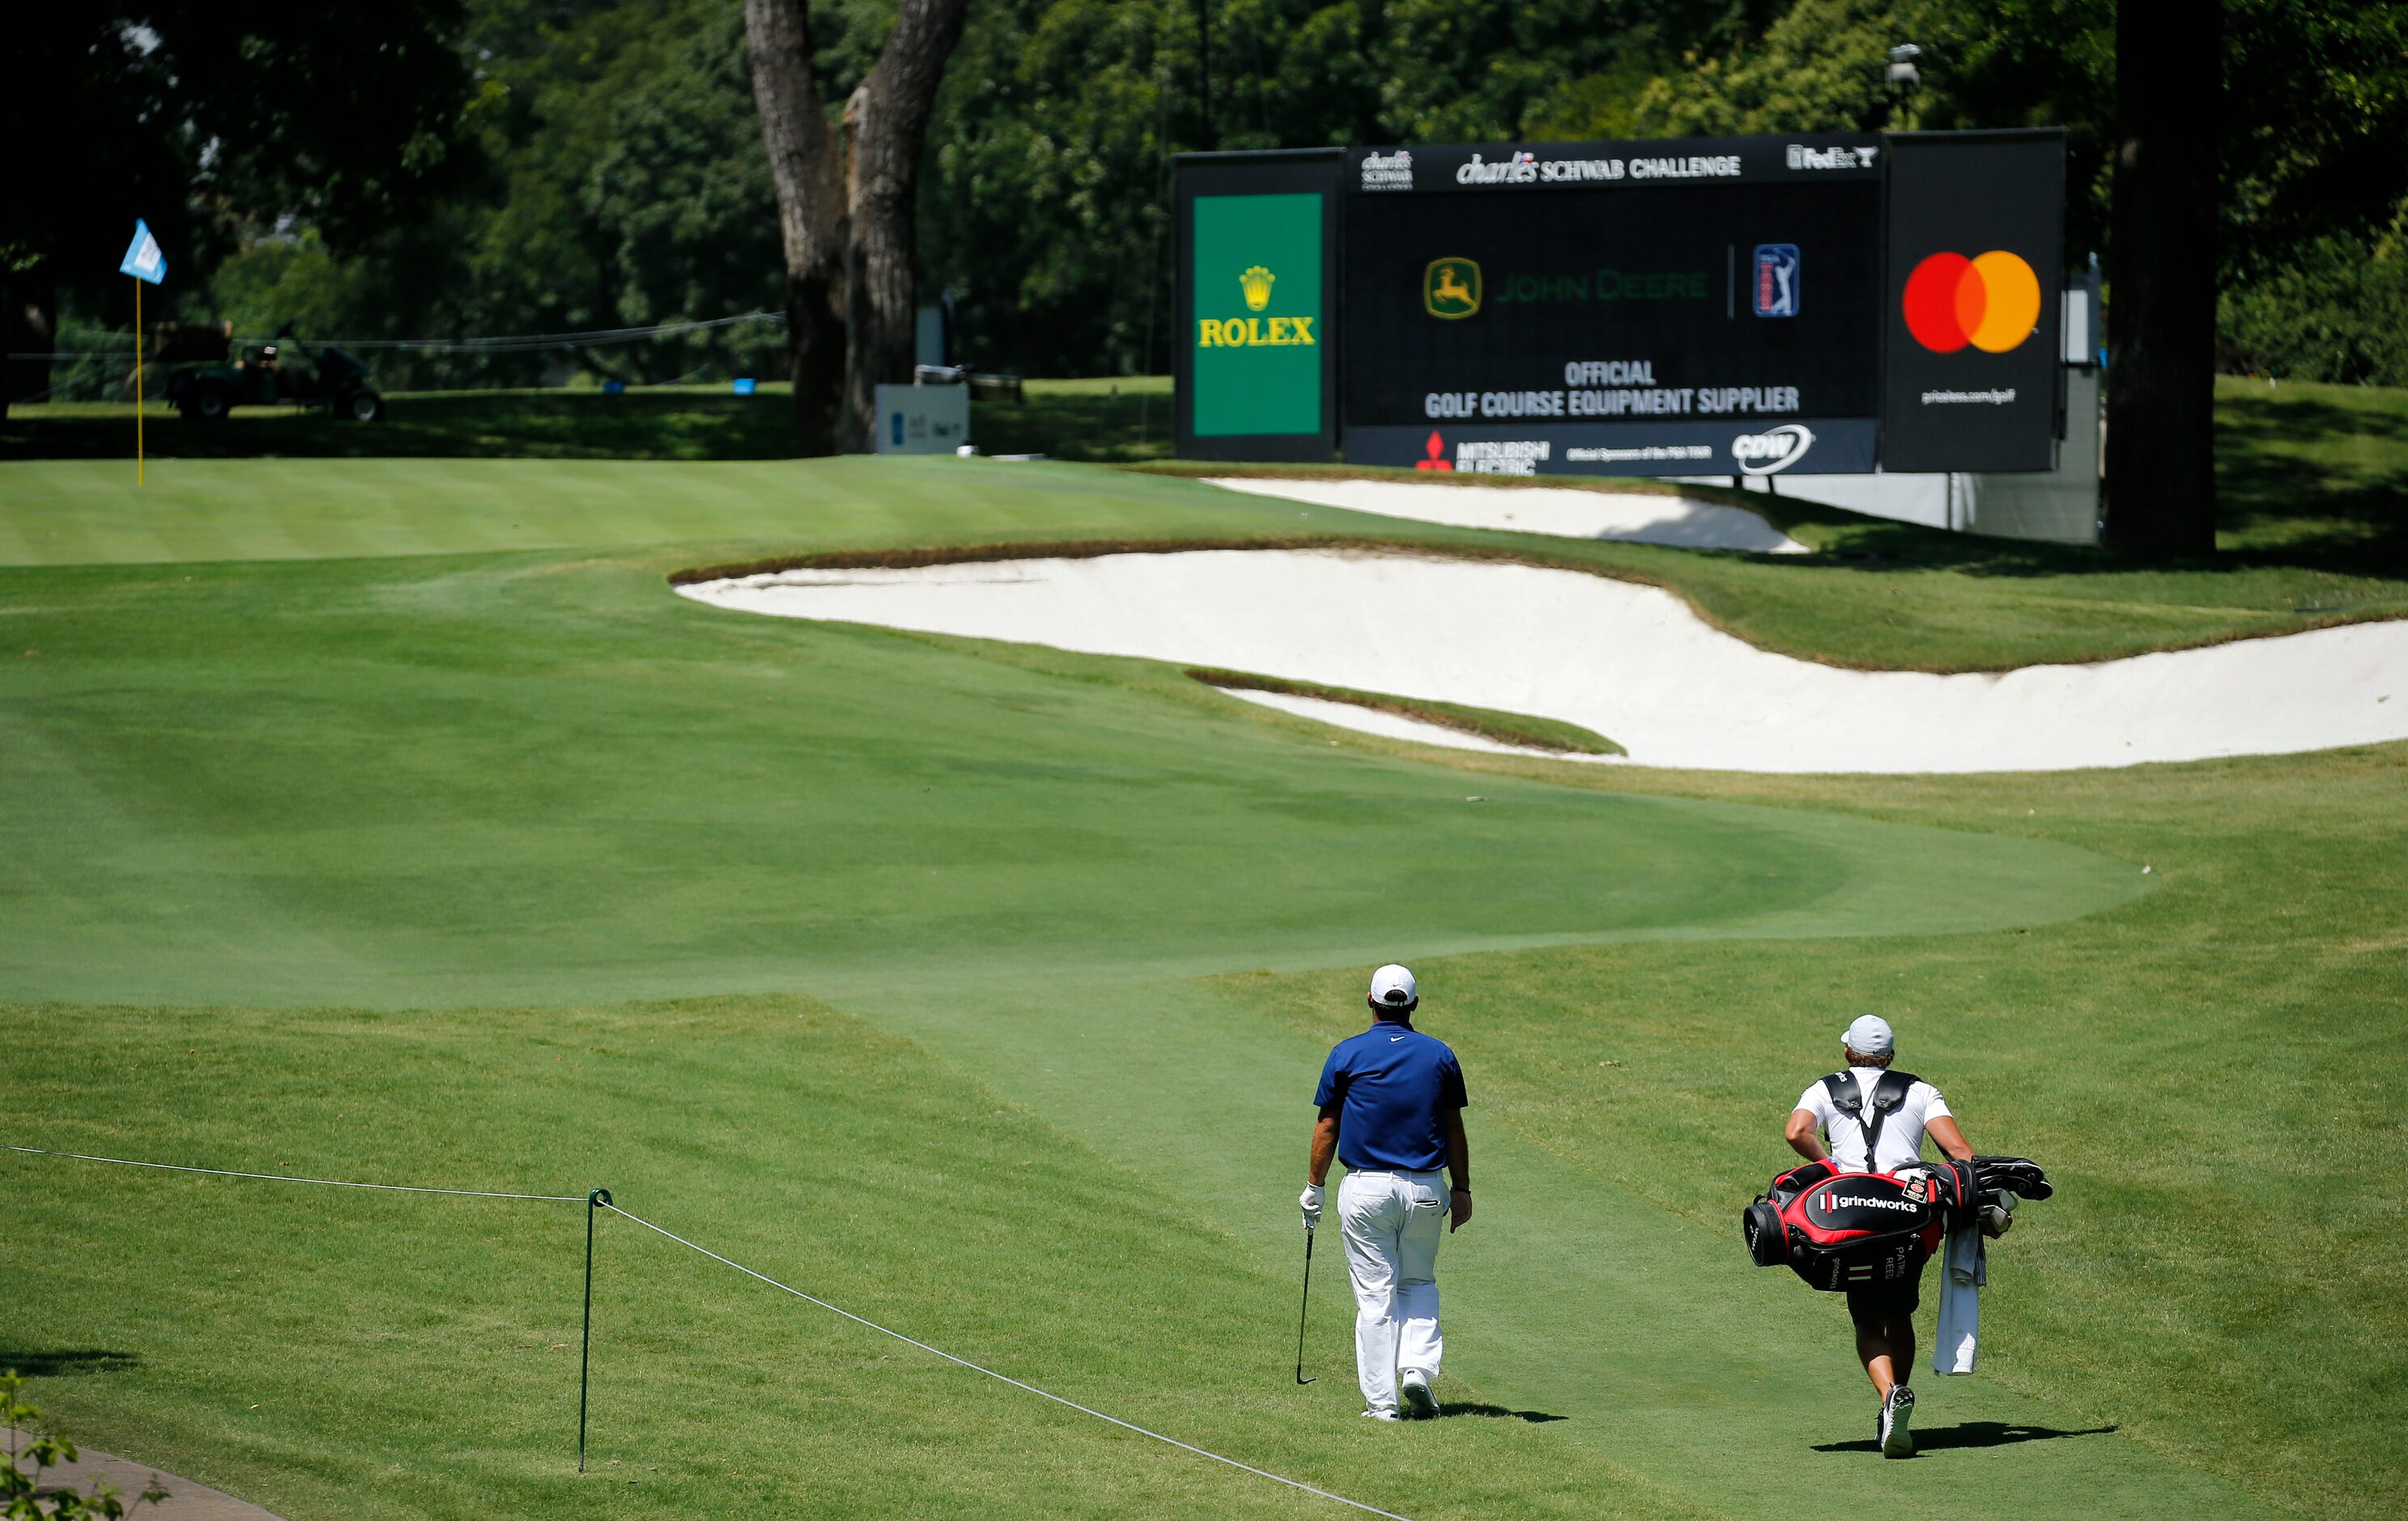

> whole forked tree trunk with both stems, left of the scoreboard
[744,0,968,454]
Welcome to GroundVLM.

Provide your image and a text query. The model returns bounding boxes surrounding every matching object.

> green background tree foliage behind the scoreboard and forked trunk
[19,0,2408,383]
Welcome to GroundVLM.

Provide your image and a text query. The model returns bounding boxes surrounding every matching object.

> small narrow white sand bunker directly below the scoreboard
[1209,475,1813,555]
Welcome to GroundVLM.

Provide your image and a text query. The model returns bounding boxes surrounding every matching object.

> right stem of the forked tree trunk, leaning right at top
[837,0,968,451]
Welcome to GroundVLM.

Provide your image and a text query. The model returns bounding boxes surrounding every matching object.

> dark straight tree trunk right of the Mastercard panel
[2104,0,2223,555]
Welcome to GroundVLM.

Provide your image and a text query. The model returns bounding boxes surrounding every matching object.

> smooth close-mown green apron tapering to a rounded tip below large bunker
[0,547,2141,1008]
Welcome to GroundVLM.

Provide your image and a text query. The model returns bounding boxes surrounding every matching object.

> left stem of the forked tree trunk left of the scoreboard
[744,0,848,456]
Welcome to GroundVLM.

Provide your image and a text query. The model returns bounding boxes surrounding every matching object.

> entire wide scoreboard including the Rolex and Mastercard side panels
[1177,130,2064,475]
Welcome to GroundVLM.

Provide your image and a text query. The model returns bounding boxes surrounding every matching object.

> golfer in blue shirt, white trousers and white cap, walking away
[1298,966,1471,1420]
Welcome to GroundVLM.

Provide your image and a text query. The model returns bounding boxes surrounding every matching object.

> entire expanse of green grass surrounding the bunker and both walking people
[0,460,2408,1521]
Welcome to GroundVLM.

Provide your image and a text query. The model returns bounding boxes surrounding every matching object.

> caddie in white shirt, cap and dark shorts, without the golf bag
[1785,1015,1972,1459]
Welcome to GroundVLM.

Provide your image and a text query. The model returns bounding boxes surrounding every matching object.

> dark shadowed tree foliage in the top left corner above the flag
[0,0,474,414]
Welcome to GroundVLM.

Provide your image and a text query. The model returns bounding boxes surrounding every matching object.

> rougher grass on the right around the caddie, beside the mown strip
[1240,745,2408,1516]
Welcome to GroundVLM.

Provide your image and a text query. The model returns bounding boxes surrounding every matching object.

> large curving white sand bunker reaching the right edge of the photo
[679,550,2408,771]
